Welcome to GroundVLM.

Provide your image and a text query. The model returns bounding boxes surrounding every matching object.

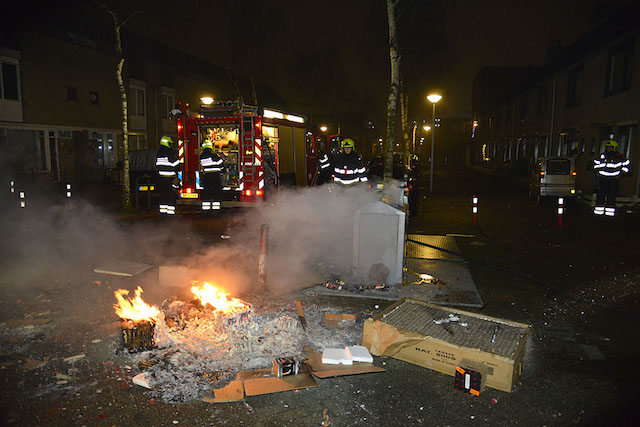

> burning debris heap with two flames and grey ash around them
[116,282,320,402]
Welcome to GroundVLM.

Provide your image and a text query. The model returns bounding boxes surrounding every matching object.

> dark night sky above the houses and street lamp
[3,0,637,132]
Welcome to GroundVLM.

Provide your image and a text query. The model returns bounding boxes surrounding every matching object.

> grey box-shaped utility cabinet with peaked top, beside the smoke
[353,196,406,285]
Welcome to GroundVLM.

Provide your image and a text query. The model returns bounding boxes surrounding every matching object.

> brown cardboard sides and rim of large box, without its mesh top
[362,299,531,392]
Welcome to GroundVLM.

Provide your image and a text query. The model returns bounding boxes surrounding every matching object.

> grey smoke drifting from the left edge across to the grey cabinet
[0,182,402,302]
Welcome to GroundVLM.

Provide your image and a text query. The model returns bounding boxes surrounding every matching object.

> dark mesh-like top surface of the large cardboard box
[382,301,527,357]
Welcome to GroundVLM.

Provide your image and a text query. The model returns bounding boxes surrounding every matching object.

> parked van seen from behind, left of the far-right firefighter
[529,156,576,203]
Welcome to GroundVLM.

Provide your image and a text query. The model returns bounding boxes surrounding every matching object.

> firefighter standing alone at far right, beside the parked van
[593,139,629,216]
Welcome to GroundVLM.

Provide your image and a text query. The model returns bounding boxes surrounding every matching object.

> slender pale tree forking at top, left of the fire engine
[99,3,143,209]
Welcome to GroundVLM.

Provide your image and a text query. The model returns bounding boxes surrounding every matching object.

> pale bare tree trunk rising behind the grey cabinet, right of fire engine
[384,0,400,181]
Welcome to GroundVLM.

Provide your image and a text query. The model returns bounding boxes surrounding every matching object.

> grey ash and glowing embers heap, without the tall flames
[119,286,362,402]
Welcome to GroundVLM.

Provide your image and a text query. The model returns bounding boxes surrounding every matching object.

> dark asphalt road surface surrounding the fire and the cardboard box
[0,169,640,426]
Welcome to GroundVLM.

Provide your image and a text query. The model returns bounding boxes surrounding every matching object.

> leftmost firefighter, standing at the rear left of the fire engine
[156,135,180,215]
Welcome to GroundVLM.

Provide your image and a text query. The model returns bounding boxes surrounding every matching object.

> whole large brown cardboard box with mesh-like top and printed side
[362,298,531,392]
